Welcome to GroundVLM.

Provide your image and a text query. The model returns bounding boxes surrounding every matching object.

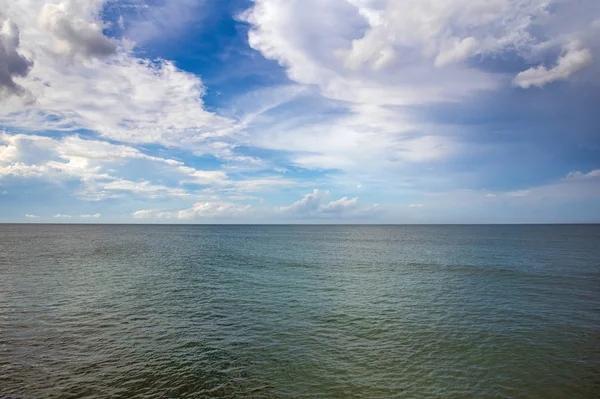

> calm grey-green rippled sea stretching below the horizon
[0,225,600,399]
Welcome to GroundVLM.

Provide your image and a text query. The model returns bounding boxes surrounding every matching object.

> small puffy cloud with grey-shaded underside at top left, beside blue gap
[38,0,117,58]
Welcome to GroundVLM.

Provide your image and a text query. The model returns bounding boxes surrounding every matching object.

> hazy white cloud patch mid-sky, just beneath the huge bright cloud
[249,105,460,180]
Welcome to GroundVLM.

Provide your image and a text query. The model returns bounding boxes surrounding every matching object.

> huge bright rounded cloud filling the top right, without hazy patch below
[241,0,598,104]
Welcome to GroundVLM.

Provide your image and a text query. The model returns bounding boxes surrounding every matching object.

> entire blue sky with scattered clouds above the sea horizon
[0,0,600,223]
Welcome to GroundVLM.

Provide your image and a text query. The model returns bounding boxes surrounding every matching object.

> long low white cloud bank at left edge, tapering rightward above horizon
[0,131,310,201]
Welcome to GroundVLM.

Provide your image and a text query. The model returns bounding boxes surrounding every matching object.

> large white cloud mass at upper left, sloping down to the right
[0,0,236,150]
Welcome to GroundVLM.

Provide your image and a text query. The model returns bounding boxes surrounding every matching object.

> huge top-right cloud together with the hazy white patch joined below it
[240,0,600,184]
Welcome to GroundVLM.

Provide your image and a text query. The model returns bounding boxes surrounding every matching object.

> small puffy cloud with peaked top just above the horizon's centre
[279,189,358,216]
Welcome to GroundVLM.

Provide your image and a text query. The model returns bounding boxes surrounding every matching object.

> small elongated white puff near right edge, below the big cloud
[513,42,592,89]
